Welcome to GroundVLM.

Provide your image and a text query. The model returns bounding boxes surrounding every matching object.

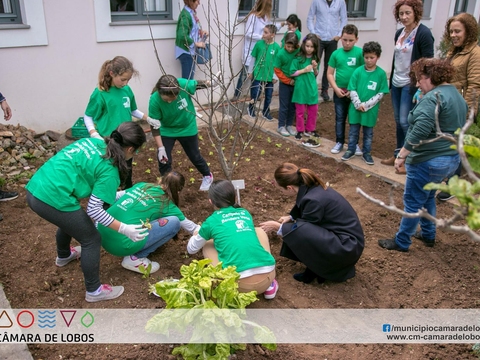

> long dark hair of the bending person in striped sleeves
[103,121,147,183]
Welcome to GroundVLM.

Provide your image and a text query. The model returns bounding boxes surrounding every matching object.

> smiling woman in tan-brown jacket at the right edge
[437,13,480,201]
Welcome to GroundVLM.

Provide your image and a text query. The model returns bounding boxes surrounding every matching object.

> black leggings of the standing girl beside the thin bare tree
[158,135,210,176]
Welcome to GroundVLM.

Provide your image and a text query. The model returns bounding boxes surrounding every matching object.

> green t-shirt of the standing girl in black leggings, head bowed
[148,79,198,137]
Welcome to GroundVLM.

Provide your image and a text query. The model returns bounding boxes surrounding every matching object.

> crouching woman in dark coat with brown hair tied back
[260,163,364,283]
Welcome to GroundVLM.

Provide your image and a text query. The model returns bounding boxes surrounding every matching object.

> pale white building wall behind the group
[0,0,480,132]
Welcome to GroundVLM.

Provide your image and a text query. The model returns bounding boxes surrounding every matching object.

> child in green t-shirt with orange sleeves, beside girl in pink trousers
[274,33,298,136]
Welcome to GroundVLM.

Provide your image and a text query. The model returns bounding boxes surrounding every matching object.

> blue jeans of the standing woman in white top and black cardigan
[391,85,414,157]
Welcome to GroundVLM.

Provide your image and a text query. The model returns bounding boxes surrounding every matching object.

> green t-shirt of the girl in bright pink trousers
[288,56,320,105]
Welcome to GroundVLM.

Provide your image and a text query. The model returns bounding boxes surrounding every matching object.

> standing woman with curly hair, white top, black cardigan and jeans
[381,0,434,174]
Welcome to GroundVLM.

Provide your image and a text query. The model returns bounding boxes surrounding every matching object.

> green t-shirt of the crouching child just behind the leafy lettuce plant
[199,207,275,272]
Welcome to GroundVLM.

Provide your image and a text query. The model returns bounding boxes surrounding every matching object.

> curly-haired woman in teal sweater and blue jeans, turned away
[378,58,467,252]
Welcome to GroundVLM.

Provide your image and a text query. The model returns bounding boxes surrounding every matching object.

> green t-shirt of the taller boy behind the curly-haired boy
[328,46,365,89]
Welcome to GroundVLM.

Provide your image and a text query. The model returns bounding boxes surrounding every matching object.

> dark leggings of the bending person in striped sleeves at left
[27,190,102,292]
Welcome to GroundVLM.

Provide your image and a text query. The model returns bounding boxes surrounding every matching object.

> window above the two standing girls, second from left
[110,0,172,22]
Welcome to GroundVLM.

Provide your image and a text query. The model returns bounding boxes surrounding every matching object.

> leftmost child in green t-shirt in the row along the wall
[248,24,280,121]
